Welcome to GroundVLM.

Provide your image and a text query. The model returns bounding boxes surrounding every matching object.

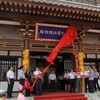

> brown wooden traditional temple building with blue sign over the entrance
[0,0,100,91]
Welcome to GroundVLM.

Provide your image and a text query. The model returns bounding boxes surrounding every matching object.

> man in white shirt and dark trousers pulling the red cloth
[34,67,42,95]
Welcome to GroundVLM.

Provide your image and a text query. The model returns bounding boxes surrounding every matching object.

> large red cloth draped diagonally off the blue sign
[47,26,77,63]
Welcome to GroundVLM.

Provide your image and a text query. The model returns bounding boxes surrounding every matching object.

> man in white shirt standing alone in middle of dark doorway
[49,70,57,92]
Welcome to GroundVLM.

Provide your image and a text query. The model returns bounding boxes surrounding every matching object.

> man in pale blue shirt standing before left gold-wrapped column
[18,66,25,86]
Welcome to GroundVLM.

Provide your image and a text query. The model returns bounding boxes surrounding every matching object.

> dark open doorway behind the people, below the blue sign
[30,52,75,90]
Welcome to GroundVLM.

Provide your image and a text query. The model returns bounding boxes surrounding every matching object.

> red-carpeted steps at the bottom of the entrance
[34,92,87,100]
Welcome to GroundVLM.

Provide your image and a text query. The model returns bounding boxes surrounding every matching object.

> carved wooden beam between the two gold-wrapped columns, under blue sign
[29,40,72,53]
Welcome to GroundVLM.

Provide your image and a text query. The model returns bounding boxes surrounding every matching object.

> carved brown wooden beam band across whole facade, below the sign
[0,39,100,54]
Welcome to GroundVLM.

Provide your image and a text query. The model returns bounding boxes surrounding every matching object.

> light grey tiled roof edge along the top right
[28,0,100,12]
